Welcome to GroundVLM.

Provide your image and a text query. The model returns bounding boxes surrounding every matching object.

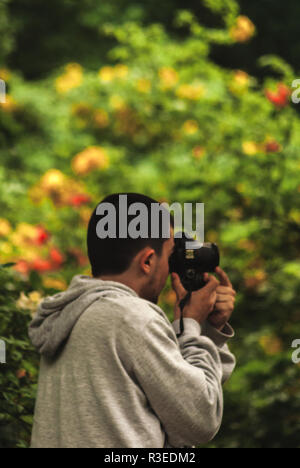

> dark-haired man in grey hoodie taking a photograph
[29,194,236,448]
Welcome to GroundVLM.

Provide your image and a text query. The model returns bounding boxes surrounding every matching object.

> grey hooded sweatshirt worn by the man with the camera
[29,276,235,448]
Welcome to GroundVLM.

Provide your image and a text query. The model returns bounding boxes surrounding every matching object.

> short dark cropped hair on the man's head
[87,193,174,277]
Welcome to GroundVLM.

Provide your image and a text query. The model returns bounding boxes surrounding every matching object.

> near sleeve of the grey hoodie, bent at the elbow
[134,316,236,447]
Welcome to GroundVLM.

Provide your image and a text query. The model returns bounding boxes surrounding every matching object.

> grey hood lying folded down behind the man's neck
[28,275,139,358]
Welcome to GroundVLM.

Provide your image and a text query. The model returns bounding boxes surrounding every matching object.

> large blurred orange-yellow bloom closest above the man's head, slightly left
[72,146,109,175]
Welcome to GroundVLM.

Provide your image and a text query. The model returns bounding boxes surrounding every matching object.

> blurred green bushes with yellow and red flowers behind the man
[0,0,300,448]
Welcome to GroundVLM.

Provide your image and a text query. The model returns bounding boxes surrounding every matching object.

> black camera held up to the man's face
[169,232,220,291]
